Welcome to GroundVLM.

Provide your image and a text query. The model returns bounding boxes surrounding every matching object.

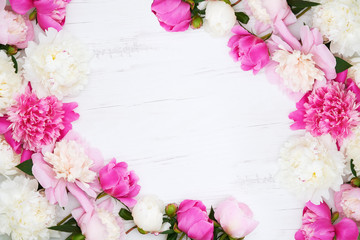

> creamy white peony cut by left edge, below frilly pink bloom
[0,136,20,176]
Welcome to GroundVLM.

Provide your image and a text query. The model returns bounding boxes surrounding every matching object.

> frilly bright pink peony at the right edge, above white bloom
[289,70,360,145]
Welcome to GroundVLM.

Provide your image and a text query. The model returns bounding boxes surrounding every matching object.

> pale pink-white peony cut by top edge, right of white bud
[244,0,297,34]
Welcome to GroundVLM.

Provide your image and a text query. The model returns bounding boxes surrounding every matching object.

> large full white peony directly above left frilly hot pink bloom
[24,28,91,99]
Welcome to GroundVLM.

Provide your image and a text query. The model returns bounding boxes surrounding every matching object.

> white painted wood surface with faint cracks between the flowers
[60,0,303,240]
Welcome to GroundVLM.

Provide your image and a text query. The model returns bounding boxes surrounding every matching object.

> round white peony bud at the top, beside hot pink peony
[204,1,236,37]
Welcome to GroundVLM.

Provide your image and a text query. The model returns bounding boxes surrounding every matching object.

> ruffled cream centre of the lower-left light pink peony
[44,140,96,184]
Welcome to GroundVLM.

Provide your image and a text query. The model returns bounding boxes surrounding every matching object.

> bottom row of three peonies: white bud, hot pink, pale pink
[132,196,258,240]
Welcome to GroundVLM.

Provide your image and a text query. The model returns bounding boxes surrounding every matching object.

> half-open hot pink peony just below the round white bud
[228,26,269,74]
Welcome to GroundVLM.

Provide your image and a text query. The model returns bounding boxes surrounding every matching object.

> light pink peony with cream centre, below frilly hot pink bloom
[32,132,104,211]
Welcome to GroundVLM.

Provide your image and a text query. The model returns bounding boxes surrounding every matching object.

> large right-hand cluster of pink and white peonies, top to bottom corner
[152,0,360,240]
